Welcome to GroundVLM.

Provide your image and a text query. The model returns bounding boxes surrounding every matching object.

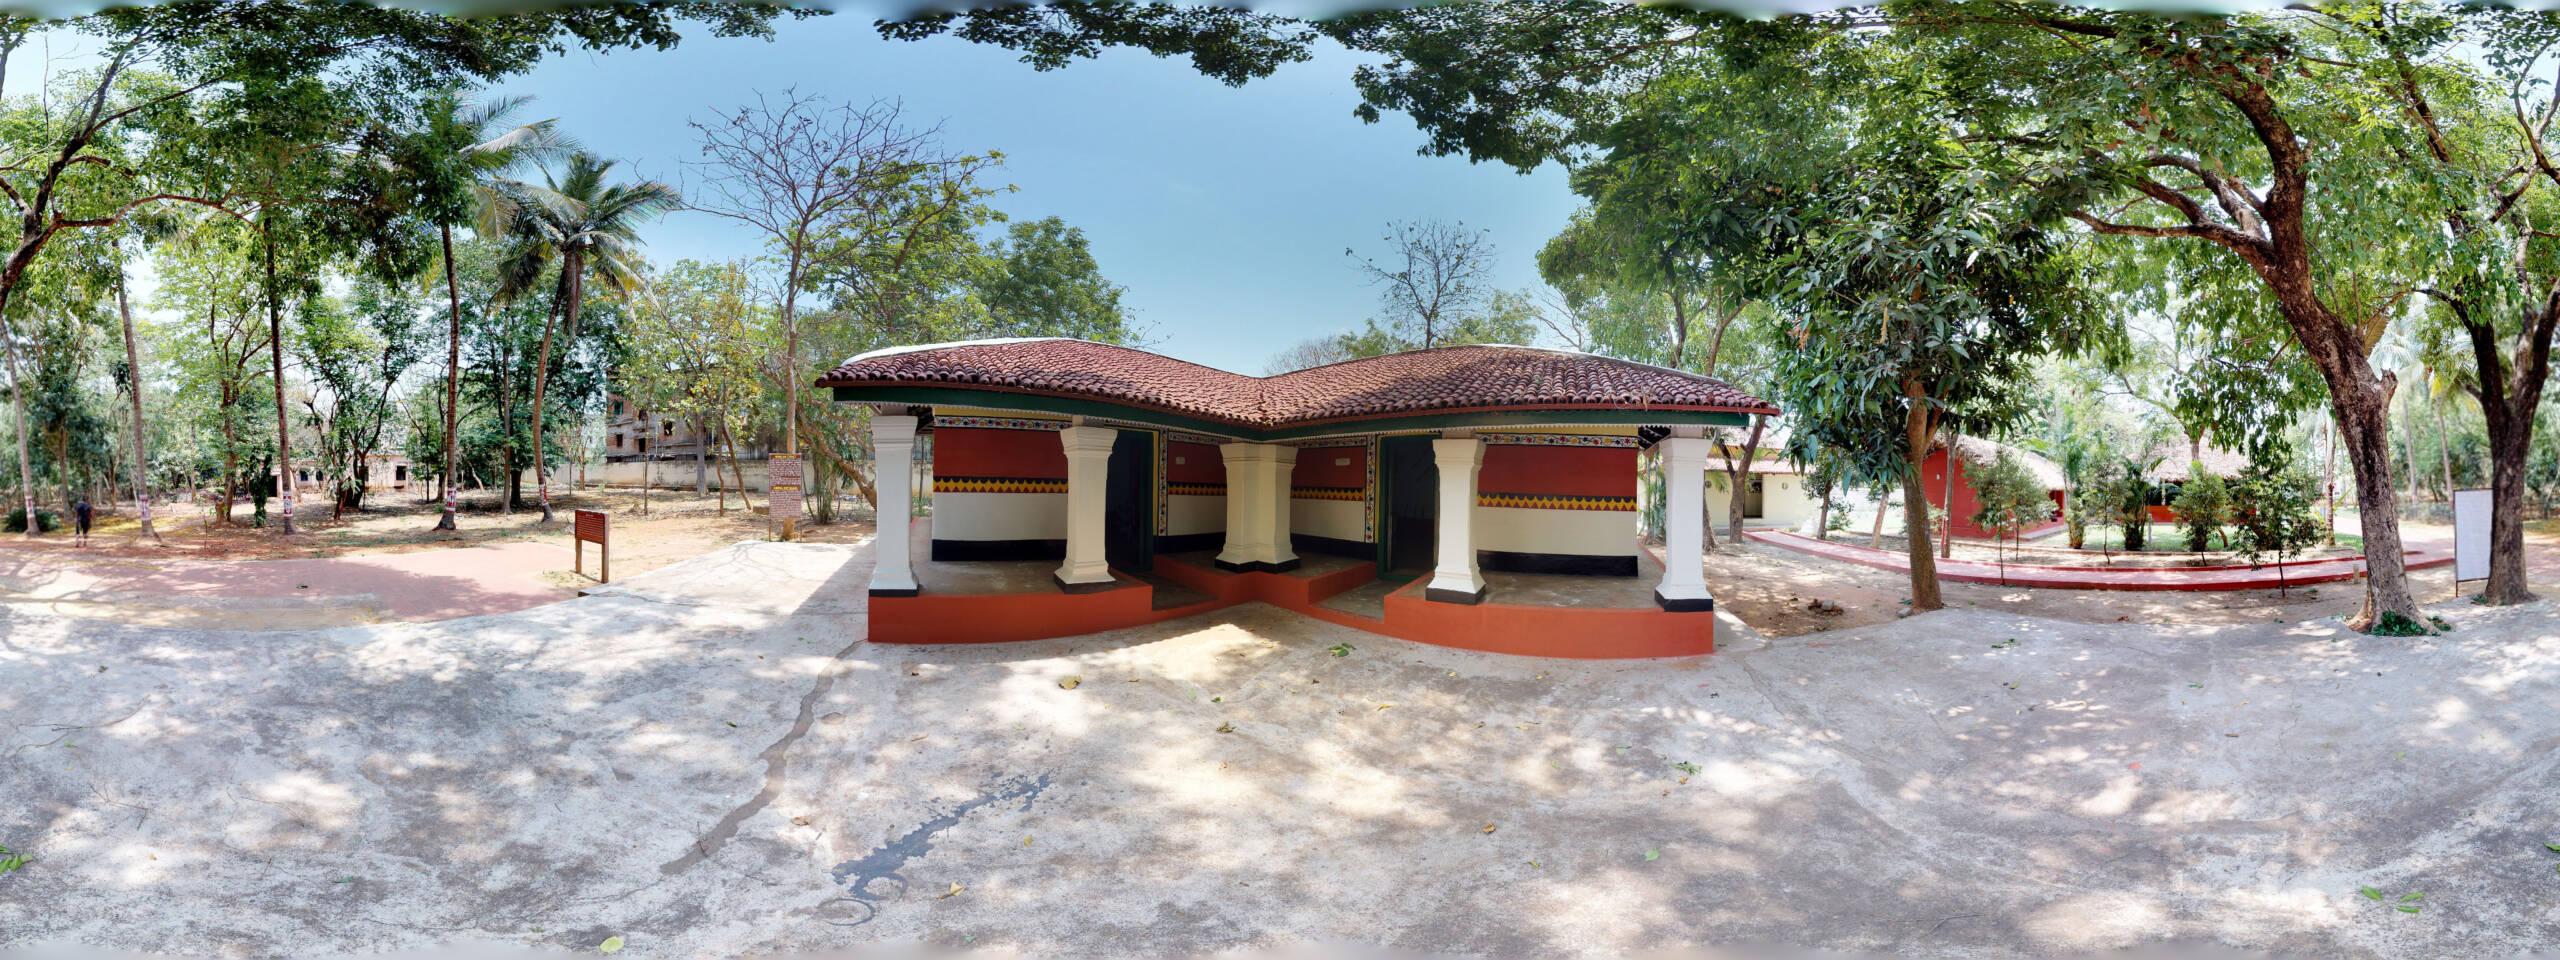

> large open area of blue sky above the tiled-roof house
[499,13,1574,374]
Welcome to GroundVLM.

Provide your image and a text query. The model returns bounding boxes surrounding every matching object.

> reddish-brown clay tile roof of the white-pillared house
[817,338,1777,428]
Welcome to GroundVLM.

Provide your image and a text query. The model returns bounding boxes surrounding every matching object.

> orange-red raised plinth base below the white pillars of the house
[870,558,1715,660]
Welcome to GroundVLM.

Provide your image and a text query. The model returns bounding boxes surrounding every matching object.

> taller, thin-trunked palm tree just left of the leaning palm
[417,90,576,530]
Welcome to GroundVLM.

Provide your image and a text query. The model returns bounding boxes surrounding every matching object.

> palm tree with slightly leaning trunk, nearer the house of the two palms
[499,154,684,522]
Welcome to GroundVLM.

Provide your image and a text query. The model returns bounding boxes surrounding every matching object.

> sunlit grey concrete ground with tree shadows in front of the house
[0,543,2560,957]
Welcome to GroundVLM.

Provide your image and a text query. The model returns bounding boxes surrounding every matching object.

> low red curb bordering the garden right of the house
[1743,530,2452,591]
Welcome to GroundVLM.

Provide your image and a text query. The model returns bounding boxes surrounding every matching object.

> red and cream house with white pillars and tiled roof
[819,338,1777,655]
